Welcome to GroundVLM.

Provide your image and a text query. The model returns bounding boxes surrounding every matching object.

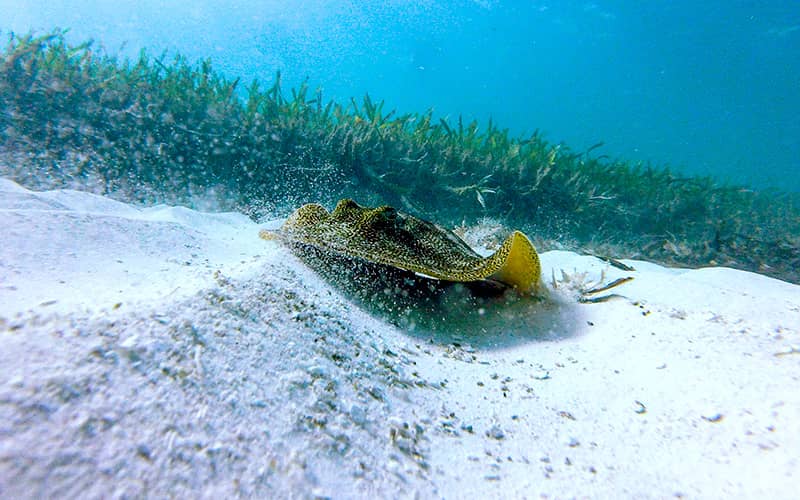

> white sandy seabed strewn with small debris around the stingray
[0,181,800,498]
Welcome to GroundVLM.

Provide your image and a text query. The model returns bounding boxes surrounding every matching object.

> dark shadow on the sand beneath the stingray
[294,245,586,349]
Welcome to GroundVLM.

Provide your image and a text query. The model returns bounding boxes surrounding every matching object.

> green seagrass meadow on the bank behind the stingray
[0,31,800,283]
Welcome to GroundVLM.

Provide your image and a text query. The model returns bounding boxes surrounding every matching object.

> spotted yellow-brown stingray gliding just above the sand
[259,199,542,295]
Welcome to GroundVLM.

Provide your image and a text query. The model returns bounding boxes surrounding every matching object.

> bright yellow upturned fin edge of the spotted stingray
[489,231,542,295]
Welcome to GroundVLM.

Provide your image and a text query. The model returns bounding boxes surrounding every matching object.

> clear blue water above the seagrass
[0,0,800,191]
